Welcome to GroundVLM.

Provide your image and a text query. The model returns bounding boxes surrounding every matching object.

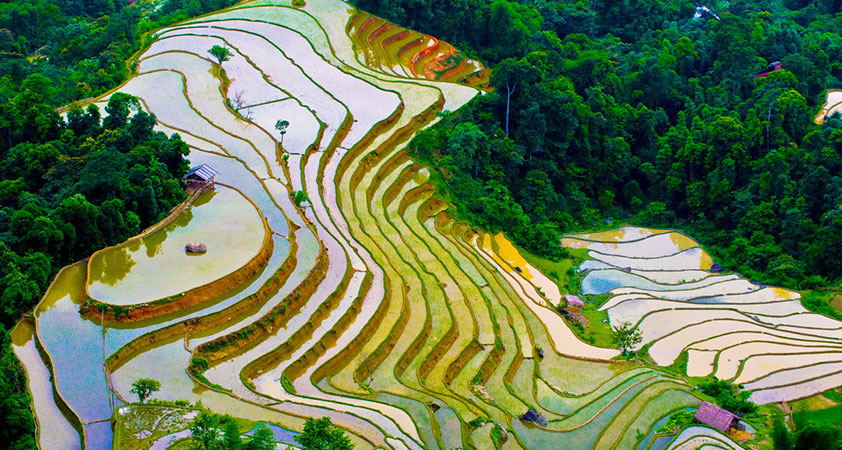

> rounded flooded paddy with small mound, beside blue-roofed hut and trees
[87,187,268,305]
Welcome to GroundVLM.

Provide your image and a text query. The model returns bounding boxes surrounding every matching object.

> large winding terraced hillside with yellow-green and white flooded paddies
[16,0,740,449]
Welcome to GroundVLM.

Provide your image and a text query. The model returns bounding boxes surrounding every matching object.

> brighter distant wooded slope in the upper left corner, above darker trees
[0,0,236,105]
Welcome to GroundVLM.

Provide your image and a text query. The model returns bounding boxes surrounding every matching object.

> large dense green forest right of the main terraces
[355,0,842,289]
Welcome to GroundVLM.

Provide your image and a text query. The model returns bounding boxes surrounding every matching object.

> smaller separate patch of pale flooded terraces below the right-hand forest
[562,228,842,406]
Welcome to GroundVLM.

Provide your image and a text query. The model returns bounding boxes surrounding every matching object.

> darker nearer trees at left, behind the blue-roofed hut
[0,80,188,448]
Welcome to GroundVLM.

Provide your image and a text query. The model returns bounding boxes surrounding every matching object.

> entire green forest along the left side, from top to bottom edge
[0,0,241,449]
